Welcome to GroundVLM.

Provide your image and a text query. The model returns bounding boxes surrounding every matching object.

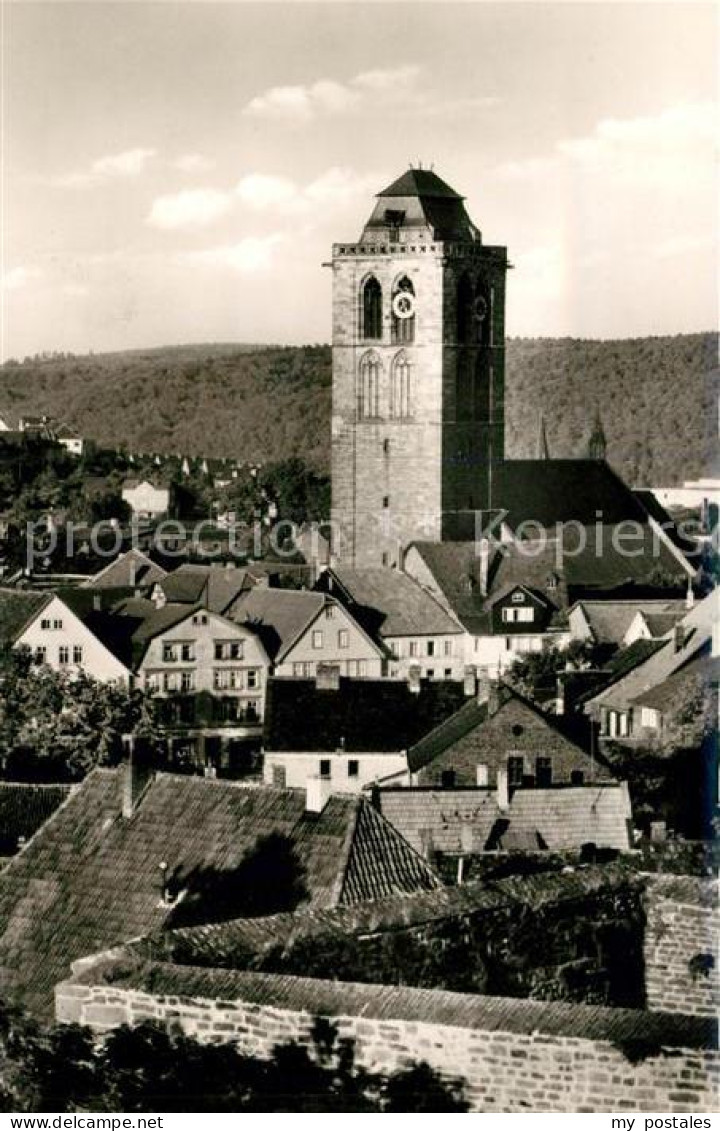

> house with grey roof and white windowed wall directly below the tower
[315,566,465,680]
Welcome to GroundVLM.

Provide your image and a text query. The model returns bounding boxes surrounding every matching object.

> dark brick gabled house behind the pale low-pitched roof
[407,683,610,789]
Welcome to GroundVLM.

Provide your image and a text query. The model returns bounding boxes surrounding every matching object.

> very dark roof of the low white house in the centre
[263,677,465,752]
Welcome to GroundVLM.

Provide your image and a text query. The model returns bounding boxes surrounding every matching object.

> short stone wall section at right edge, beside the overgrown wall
[644,875,720,1017]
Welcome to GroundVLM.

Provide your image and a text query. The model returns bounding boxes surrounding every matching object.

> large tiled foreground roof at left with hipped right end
[0,769,440,1018]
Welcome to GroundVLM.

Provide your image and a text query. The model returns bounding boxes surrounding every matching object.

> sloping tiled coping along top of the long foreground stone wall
[72,962,718,1050]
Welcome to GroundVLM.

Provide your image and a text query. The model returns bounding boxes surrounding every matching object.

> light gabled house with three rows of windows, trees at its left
[132,604,270,765]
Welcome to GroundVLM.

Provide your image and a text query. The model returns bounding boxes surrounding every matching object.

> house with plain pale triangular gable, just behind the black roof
[231,586,387,679]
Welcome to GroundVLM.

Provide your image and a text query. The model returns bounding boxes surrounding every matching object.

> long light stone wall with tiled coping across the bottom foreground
[57,962,720,1112]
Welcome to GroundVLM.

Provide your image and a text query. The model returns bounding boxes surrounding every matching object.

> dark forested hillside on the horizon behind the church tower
[0,334,720,484]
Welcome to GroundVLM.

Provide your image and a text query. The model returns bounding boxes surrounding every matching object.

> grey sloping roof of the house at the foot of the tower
[322,566,462,638]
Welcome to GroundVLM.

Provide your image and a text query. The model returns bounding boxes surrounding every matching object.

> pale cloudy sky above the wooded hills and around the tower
[0,0,718,359]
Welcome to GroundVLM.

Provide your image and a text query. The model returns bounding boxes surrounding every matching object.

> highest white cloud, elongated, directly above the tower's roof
[243,64,474,122]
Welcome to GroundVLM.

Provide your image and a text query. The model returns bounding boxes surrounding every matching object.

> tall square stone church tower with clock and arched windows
[332,169,508,566]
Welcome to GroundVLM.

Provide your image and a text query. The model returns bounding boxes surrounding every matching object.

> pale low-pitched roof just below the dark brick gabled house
[378,783,632,855]
